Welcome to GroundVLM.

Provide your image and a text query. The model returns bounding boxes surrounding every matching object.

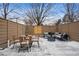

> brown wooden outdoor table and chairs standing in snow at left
[12,35,39,52]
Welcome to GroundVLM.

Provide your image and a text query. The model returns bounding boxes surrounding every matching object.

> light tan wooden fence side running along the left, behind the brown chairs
[0,19,25,48]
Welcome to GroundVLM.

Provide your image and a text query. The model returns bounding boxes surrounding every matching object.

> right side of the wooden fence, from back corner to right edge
[58,22,79,41]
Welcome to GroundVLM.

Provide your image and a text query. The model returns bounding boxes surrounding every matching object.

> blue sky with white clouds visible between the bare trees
[0,3,64,24]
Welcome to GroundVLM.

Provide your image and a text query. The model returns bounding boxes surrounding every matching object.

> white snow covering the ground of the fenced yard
[0,38,79,56]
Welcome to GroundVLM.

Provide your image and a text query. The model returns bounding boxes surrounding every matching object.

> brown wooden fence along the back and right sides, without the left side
[26,22,79,41]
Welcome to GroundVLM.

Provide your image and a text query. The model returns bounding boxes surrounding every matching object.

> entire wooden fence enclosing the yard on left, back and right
[0,19,79,48]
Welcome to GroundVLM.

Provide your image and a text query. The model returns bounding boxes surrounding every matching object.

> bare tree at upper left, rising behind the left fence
[0,3,20,20]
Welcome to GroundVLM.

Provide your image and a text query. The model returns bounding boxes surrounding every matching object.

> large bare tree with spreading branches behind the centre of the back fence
[26,3,52,25]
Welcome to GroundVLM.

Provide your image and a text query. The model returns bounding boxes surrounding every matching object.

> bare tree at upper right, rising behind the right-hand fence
[63,3,78,22]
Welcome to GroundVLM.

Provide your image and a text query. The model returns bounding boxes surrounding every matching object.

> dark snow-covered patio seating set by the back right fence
[44,32,70,41]
